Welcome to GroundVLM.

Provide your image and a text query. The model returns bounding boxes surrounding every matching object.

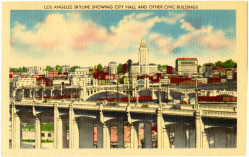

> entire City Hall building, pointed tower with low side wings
[131,39,157,75]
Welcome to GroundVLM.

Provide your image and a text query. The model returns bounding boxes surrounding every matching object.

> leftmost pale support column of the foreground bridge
[11,105,21,149]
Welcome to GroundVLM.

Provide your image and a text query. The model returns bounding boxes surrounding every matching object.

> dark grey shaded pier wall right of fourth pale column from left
[79,117,94,148]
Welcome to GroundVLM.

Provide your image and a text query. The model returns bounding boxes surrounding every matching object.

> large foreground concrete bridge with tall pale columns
[10,100,237,149]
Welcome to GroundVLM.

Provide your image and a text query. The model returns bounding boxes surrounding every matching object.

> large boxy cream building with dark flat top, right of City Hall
[176,58,198,75]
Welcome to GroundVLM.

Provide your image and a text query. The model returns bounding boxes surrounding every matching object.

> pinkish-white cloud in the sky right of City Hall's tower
[151,19,235,53]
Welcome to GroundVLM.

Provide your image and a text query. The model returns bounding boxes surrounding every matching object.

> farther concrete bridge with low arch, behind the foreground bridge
[11,81,237,101]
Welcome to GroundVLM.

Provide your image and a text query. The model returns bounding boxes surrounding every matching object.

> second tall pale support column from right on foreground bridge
[157,108,164,148]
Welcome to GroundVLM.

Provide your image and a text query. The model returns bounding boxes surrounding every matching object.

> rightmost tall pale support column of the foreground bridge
[195,110,202,148]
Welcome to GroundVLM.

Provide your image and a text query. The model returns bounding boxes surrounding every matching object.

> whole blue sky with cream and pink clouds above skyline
[10,10,236,66]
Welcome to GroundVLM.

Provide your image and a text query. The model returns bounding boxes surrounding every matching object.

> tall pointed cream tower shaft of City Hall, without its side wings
[138,39,149,74]
